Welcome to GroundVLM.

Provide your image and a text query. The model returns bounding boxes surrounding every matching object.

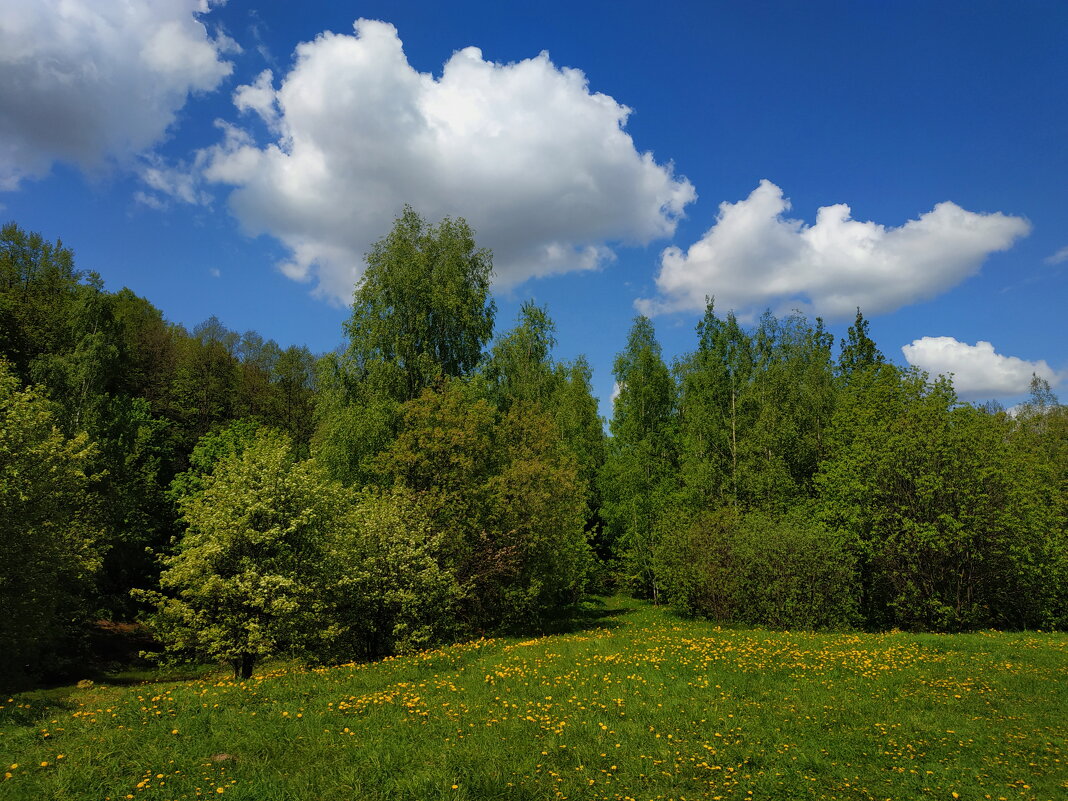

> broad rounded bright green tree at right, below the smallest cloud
[816,365,1063,630]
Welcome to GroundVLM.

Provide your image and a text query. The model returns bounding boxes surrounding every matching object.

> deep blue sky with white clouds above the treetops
[0,0,1068,413]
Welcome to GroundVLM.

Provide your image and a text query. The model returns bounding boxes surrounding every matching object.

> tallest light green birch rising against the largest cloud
[312,206,496,486]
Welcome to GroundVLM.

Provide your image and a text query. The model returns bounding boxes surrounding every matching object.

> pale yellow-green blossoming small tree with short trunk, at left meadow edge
[142,430,348,675]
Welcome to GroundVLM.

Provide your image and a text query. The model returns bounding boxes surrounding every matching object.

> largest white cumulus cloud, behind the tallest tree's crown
[204,19,696,301]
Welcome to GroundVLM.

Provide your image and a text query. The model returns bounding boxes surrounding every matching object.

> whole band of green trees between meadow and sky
[0,208,1068,689]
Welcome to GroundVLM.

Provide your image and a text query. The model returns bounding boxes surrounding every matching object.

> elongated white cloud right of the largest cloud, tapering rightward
[637,180,1031,318]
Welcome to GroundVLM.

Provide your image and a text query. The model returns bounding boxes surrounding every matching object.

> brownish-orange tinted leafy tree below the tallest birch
[379,381,588,627]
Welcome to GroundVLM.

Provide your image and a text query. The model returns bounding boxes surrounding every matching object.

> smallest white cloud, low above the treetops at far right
[901,336,1062,399]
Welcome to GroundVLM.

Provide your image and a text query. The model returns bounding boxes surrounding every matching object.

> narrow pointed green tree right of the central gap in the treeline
[601,316,676,600]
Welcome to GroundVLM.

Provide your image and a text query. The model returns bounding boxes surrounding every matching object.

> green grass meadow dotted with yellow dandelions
[0,599,1068,801]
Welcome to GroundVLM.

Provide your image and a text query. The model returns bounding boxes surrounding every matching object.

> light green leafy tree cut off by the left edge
[0,360,98,687]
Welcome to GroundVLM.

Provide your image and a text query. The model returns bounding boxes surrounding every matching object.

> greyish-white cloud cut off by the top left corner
[0,0,237,190]
